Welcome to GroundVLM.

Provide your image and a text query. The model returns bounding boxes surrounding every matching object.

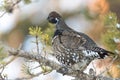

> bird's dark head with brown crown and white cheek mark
[47,11,61,24]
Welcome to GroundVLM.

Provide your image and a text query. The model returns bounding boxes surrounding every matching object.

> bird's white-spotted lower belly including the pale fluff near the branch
[56,51,93,71]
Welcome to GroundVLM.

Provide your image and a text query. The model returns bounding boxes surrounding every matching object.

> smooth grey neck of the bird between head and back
[56,19,72,30]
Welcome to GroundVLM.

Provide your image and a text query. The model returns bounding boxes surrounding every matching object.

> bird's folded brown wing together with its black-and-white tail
[53,30,112,58]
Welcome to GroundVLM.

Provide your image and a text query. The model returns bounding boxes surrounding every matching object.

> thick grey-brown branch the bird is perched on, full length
[8,49,119,80]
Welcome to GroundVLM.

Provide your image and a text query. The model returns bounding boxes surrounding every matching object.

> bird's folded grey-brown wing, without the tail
[53,30,96,49]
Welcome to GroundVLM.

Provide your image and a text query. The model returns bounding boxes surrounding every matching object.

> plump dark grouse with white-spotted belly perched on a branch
[47,11,114,71]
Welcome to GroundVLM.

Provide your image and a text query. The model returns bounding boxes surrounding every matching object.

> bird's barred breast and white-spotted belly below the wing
[52,37,96,68]
